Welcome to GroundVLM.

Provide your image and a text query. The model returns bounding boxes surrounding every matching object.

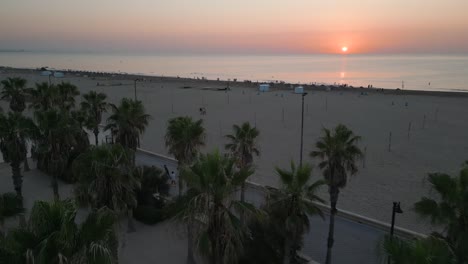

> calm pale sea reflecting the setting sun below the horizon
[0,51,468,92]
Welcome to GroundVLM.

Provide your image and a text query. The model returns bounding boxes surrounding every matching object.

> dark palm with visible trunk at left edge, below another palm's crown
[0,112,34,205]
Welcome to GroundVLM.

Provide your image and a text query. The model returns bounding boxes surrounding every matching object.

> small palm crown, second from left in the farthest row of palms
[29,82,58,111]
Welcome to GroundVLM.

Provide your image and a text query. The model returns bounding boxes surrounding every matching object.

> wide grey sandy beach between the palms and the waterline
[0,68,468,233]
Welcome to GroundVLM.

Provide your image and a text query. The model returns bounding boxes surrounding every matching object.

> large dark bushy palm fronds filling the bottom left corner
[0,200,118,264]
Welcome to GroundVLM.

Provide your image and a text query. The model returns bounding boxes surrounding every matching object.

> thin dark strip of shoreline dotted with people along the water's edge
[0,65,468,97]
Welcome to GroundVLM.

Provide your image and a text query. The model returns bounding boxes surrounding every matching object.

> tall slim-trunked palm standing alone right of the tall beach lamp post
[310,124,362,264]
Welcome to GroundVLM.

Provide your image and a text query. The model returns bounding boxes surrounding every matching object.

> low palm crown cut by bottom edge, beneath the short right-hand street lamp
[381,236,456,264]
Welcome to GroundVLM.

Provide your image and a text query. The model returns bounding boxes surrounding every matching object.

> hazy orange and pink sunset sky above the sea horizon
[0,0,468,54]
